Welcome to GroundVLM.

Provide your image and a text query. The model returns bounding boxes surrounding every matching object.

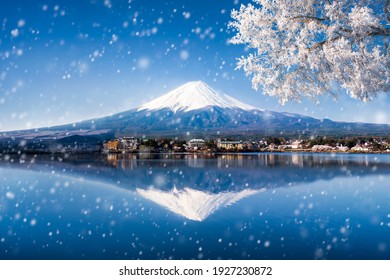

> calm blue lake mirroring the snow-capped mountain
[0,153,390,259]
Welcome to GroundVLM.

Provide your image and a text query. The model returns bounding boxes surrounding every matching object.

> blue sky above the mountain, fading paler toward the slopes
[0,0,390,131]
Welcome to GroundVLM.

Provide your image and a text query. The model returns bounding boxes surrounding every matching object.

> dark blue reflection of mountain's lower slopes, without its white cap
[0,153,390,193]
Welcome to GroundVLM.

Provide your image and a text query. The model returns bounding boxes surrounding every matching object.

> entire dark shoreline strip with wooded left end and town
[0,135,390,154]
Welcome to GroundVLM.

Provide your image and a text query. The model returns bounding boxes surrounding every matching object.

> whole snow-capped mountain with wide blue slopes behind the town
[1,81,390,140]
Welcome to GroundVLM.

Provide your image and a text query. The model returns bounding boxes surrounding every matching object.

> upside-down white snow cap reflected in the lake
[137,188,264,222]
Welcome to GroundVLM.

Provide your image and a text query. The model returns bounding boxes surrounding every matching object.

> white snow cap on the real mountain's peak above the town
[138,81,259,113]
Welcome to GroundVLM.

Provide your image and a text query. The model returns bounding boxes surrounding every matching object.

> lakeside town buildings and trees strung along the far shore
[102,137,390,153]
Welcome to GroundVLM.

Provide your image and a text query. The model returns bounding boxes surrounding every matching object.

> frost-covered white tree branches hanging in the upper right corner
[229,0,390,103]
